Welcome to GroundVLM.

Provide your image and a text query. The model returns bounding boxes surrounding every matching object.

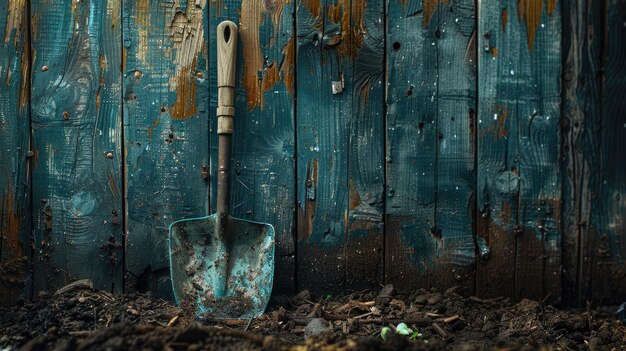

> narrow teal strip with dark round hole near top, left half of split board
[385,0,442,290]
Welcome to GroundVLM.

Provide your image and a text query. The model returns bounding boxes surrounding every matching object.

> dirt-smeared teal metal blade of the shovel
[169,214,275,319]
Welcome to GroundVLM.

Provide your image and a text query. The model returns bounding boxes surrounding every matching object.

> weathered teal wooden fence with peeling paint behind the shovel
[0,0,626,303]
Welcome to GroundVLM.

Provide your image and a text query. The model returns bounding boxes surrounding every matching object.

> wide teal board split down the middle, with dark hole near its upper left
[385,1,476,292]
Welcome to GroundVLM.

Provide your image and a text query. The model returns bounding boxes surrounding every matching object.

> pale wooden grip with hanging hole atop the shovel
[217,21,237,134]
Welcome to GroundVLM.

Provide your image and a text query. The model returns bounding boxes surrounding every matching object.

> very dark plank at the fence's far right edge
[591,0,626,303]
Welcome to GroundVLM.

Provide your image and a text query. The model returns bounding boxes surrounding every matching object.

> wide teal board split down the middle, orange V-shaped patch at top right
[477,1,561,298]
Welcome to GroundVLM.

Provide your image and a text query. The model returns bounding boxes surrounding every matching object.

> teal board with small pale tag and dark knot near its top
[296,1,354,291]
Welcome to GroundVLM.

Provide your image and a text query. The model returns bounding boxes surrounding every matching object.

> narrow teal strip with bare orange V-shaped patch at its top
[512,0,561,300]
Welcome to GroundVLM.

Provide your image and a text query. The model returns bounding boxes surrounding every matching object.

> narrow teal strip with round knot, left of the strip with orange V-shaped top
[476,1,525,297]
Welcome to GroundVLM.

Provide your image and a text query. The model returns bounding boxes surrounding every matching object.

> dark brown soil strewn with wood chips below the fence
[0,281,626,351]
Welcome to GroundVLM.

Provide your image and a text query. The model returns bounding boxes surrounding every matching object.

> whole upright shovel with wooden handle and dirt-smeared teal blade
[169,21,274,319]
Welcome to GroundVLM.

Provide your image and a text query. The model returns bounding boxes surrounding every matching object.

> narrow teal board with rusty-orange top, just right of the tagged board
[344,0,385,290]
